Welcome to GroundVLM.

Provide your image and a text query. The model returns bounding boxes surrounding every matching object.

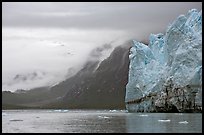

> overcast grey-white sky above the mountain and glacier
[2,2,202,91]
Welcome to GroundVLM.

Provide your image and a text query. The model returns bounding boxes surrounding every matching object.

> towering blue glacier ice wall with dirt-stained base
[125,9,202,112]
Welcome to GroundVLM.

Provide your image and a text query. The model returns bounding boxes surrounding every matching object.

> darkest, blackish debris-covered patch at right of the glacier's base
[155,80,202,112]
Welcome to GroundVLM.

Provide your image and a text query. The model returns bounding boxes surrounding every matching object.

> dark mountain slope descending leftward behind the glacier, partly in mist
[2,43,130,109]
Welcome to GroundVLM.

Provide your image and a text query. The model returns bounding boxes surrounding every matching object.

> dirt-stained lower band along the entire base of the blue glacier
[126,78,202,113]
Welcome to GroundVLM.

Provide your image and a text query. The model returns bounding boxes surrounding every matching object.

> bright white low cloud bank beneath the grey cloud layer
[2,28,131,91]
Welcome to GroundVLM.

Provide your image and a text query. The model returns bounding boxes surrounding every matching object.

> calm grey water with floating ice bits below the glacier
[2,110,202,133]
